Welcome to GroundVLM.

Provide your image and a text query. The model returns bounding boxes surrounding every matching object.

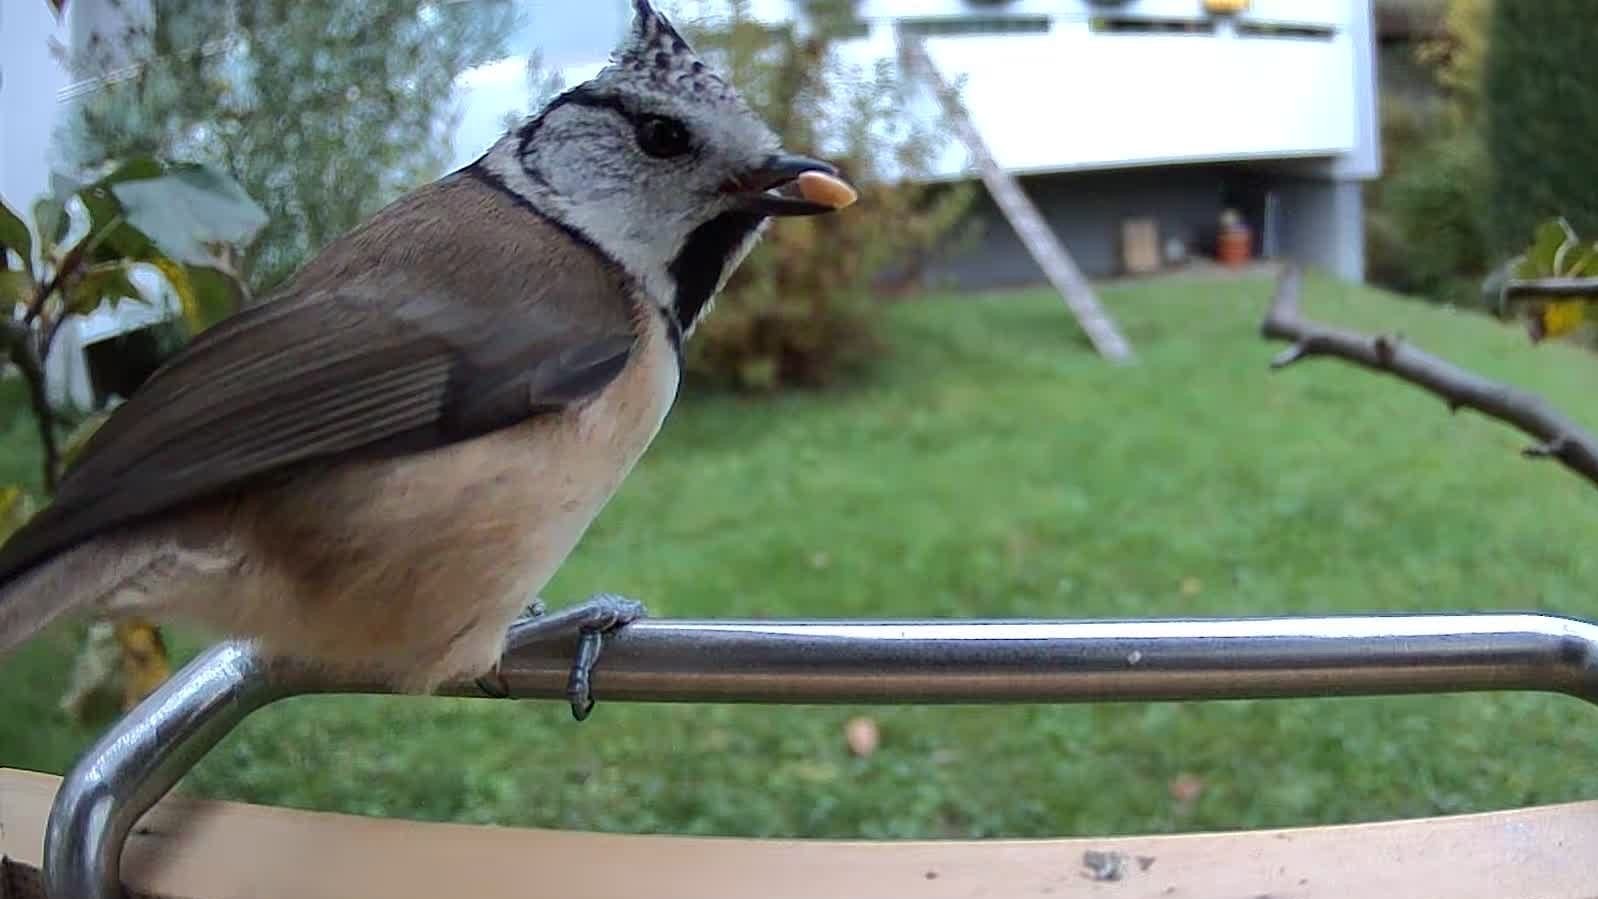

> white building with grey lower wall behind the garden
[0,0,1381,400]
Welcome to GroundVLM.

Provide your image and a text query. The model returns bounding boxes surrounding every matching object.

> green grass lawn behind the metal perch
[0,269,1598,838]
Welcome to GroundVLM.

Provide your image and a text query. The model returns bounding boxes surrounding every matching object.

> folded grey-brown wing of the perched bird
[0,284,634,583]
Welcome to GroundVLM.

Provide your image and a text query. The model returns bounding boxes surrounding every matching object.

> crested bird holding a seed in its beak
[0,0,858,720]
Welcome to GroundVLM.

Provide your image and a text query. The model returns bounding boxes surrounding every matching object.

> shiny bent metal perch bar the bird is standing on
[43,615,1598,899]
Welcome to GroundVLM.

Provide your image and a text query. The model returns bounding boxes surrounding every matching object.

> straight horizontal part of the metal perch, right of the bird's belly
[447,615,1598,704]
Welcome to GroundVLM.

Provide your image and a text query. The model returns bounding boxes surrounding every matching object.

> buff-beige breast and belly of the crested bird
[211,306,678,683]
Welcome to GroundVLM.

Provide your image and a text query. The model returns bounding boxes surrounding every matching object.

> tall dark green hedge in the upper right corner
[1483,0,1598,257]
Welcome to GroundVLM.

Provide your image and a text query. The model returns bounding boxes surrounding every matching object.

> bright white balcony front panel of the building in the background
[907,22,1358,176]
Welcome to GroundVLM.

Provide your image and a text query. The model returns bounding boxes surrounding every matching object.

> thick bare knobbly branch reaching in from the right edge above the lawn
[1261,263,1598,487]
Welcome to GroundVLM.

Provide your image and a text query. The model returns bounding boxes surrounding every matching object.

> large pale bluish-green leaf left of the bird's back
[110,163,267,265]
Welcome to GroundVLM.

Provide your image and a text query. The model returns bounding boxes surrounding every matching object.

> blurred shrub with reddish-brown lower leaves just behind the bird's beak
[686,0,972,391]
